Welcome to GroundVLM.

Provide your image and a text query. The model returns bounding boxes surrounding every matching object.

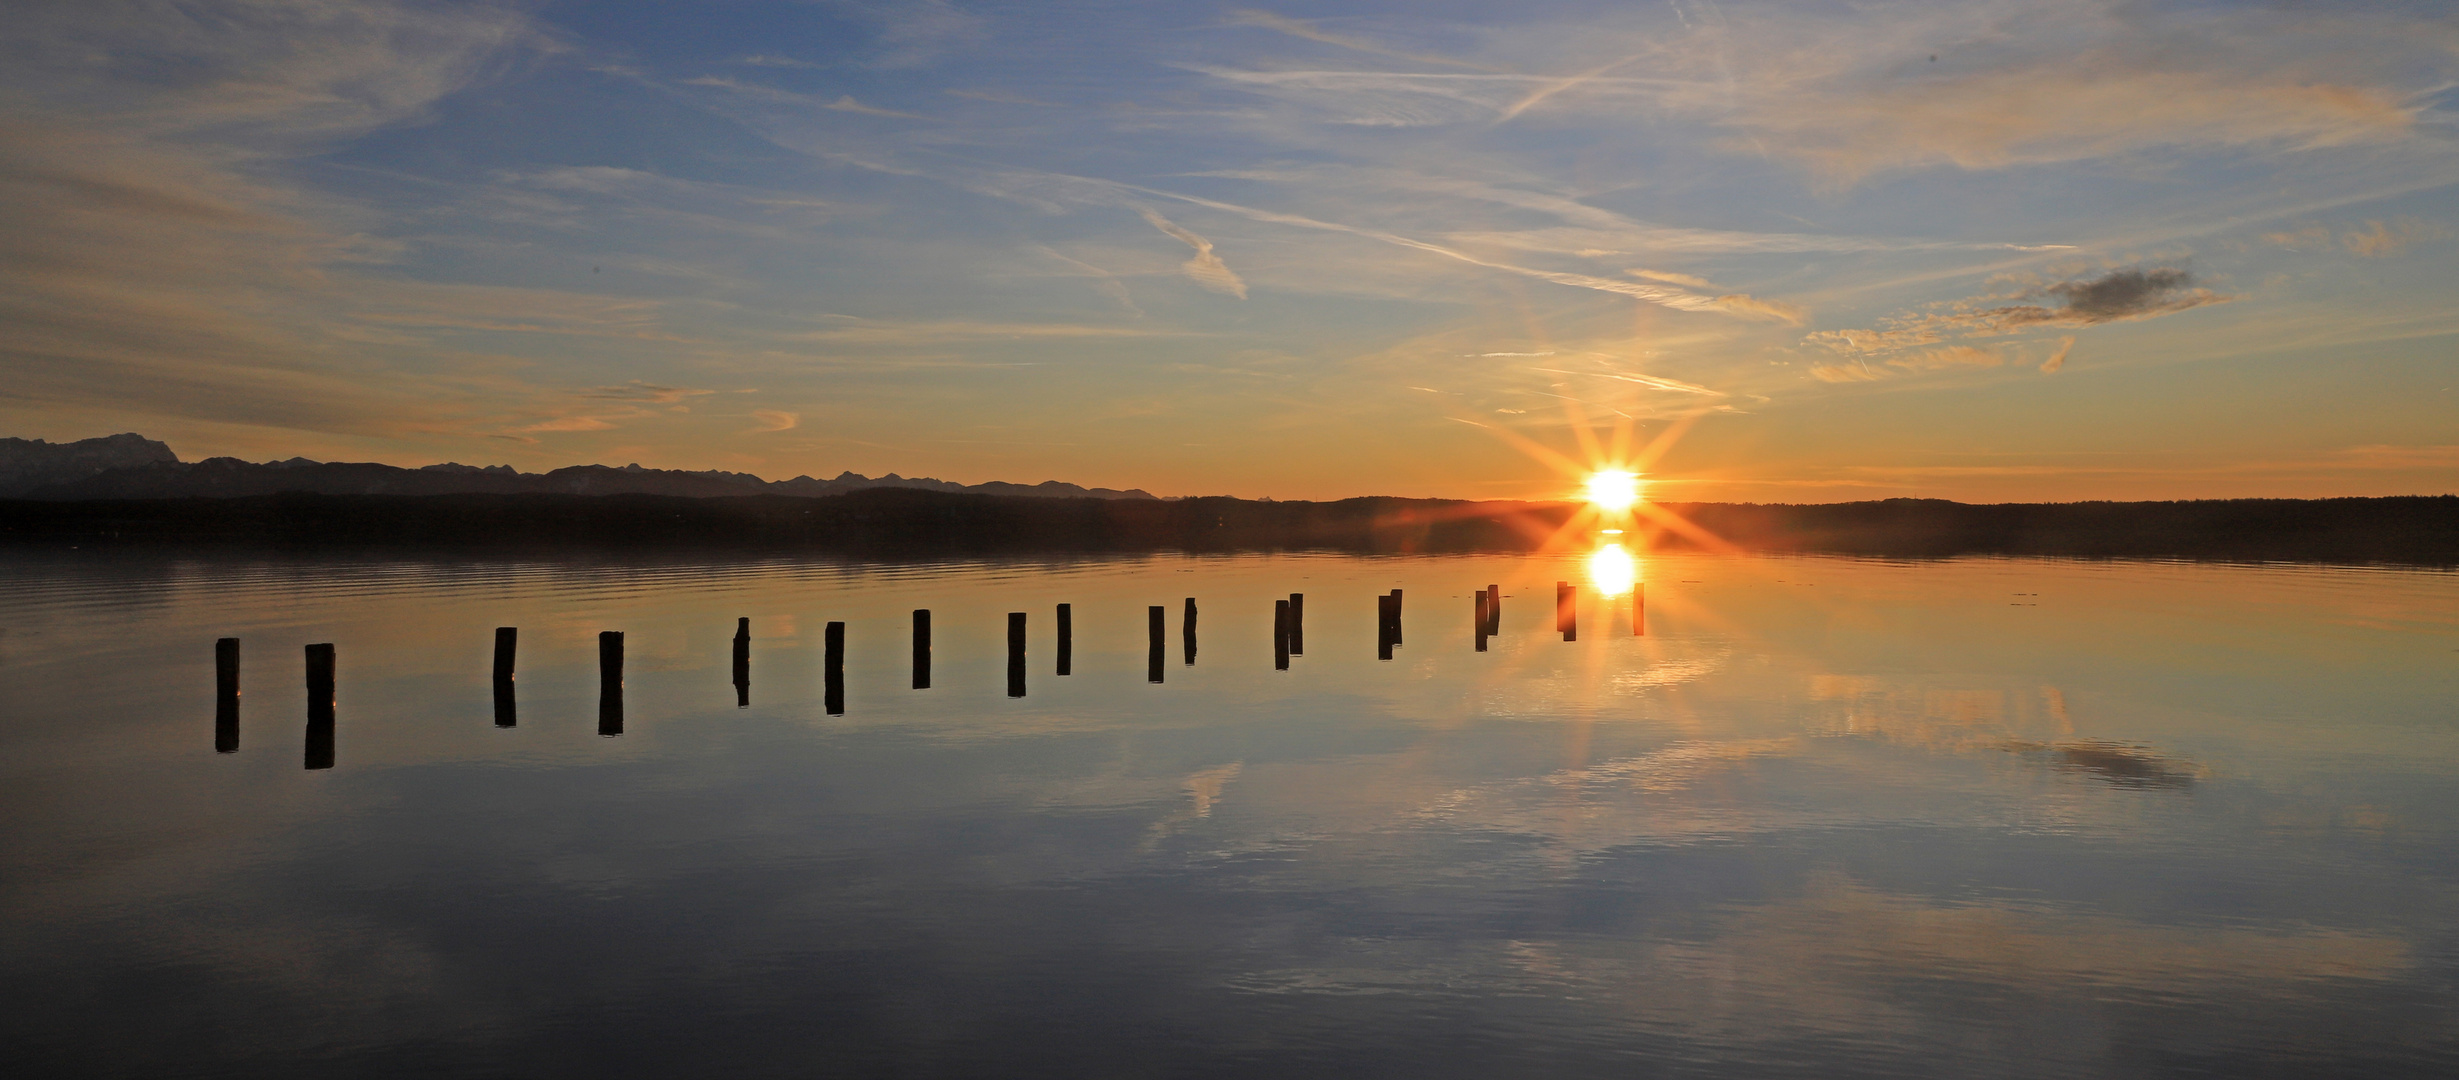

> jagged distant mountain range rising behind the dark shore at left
[0,433,1153,502]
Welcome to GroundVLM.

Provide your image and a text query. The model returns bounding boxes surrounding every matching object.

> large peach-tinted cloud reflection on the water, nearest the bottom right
[1225,873,2412,1038]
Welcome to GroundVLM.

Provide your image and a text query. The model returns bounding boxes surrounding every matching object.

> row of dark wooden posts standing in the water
[214,581,1648,768]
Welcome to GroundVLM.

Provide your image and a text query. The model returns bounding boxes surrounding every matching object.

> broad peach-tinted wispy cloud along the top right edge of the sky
[1202,0,2449,187]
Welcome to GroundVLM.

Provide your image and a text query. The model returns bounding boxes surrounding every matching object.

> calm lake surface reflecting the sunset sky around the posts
[0,551,2459,1078]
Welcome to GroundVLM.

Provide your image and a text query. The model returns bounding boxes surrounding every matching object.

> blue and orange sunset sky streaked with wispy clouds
[0,0,2459,502]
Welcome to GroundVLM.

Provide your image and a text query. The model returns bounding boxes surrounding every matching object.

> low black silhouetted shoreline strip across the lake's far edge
[0,487,2459,566]
